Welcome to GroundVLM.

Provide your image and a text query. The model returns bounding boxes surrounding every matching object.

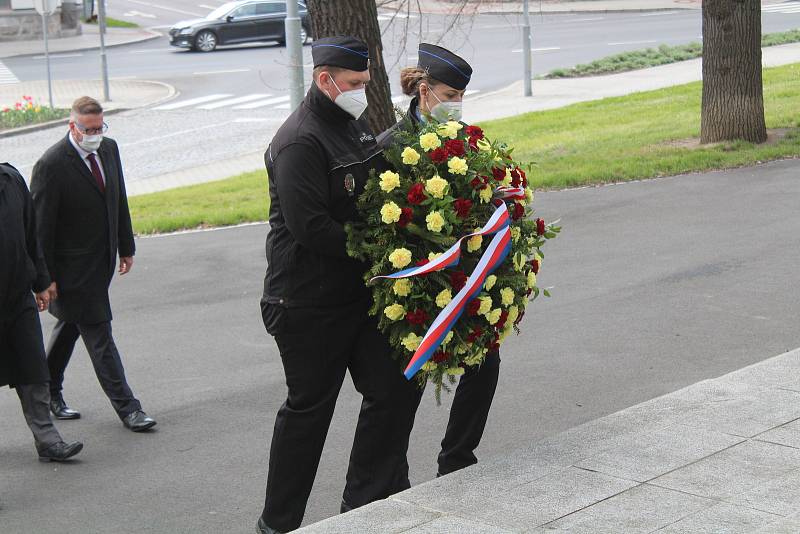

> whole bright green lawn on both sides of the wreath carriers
[130,63,800,234]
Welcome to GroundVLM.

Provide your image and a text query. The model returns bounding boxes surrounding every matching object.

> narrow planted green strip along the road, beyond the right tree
[543,29,800,78]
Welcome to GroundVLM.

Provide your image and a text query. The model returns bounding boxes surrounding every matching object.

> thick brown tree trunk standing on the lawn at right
[700,0,767,143]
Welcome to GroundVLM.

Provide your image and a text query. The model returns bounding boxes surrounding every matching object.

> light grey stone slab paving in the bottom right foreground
[297,349,800,534]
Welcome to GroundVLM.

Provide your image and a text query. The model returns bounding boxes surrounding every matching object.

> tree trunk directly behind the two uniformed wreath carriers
[307,0,395,134]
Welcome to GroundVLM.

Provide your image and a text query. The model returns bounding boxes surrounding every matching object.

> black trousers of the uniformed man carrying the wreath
[262,301,420,532]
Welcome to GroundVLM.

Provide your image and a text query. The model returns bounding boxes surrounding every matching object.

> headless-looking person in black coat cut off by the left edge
[0,163,83,462]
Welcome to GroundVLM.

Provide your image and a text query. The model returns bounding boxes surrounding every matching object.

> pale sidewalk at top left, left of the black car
[0,24,163,59]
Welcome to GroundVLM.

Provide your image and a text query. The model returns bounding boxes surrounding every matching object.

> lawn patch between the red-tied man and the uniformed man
[128,171,269,234]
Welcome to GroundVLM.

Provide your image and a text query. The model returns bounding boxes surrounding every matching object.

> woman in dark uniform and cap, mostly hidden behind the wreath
[378,43,500,482]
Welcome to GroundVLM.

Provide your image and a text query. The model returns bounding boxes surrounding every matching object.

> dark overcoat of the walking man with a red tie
[31,134,136,324]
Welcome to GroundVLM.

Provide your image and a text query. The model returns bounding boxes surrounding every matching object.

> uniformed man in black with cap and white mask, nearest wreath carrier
[258,37,418,533]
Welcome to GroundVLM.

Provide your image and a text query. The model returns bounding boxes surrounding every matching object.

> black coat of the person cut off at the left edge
[0,163,50,386]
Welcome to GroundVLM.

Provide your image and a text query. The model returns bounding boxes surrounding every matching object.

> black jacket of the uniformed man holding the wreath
[264,84,386,307]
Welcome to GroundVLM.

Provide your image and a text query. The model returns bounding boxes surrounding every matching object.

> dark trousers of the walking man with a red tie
[47,320,142,419]
